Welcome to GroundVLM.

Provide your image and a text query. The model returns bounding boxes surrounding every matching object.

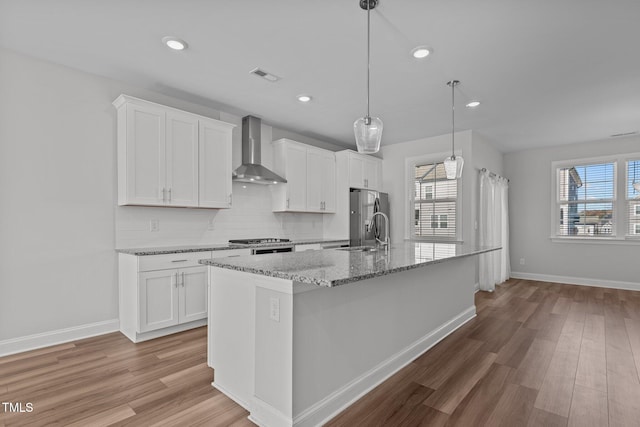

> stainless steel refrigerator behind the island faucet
[349,188,389,246]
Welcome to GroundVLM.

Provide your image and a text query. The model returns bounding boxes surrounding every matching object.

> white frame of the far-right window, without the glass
[550,153,640,244]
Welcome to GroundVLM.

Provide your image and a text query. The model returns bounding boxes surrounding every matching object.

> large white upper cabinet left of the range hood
[113,95,235,208]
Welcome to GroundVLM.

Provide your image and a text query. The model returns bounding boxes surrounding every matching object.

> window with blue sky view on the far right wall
[552,153,640,240]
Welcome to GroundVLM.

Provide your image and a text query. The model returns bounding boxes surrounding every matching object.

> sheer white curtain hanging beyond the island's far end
[478,171,511,292]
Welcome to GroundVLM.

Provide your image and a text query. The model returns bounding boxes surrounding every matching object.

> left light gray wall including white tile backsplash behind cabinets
[0,49,333,353]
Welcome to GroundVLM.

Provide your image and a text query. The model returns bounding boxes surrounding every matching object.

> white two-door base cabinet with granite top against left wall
[119,249,251,342]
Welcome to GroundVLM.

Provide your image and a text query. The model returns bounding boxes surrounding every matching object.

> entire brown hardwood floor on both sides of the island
[0,280,640,427]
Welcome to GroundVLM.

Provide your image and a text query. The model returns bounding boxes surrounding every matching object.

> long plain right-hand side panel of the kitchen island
[293,257,475,425]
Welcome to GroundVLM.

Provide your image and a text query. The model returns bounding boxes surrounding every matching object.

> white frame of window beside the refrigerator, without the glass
[404,150,463,243]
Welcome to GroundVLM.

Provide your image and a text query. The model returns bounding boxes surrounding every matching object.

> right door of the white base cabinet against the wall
[178,266,207,323]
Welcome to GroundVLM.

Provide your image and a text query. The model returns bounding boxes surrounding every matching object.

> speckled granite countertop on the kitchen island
[199,241,501,287]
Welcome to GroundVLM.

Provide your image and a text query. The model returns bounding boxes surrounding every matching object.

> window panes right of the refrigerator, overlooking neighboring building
[411,162,459,240]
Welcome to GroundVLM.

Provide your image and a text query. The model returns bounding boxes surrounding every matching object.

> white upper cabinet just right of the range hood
[272,138,336,213]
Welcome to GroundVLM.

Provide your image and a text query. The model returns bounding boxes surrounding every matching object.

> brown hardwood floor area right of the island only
[327,279,640,427]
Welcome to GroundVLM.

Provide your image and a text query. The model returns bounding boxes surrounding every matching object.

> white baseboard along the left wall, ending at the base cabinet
[0,319,120,357]
